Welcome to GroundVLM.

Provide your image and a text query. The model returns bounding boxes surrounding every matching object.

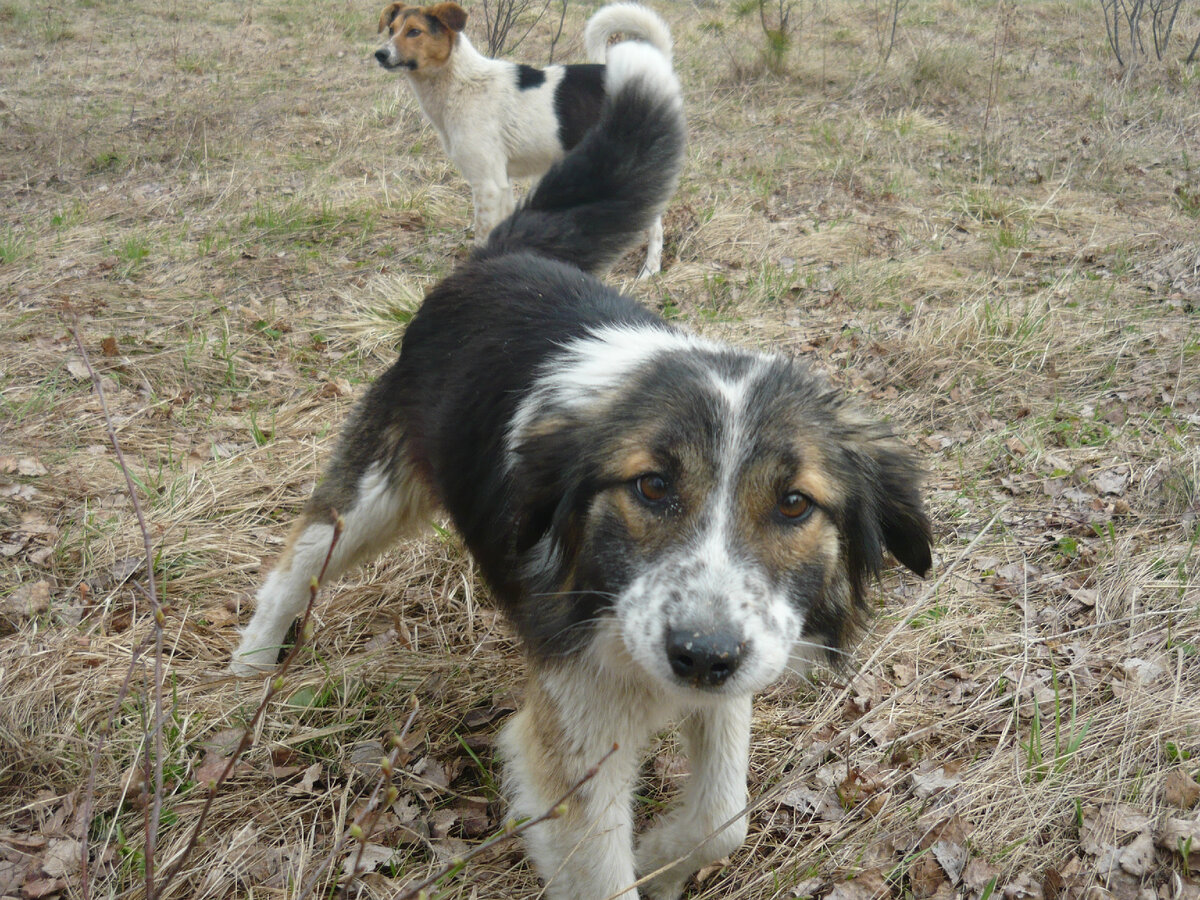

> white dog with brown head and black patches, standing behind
[376,2,671,278]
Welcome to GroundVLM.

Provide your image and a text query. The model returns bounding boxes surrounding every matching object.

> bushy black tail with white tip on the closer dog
[476,41,686,272]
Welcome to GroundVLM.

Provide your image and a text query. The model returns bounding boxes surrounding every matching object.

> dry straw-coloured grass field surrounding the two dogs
[0,0,1200,900]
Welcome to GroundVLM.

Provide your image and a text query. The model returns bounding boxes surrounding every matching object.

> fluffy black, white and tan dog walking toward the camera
[233,42,930,900]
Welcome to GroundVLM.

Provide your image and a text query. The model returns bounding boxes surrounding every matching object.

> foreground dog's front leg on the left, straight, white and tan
[500,674,643,900]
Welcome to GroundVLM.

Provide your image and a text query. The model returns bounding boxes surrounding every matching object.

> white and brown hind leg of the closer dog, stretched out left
[230,377,432,676]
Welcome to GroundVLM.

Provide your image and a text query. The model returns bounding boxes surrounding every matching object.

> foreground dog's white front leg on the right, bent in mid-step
[637,696,750,900]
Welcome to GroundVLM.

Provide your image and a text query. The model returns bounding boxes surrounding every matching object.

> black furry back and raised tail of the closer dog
[395,43,685,595]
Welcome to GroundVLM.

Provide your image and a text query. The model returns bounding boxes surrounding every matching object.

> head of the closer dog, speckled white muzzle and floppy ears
[508,326,931,694]
